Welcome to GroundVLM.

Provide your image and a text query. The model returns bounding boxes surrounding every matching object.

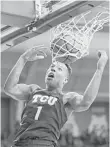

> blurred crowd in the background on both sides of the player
[1,122,109,147]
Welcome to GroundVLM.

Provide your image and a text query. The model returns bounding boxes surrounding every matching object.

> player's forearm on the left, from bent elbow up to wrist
[4,56,27,91]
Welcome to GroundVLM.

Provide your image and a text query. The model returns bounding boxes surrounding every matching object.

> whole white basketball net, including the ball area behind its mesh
[51,3,109,62]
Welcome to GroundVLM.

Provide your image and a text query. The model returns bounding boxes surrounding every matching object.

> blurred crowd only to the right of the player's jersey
[59,127,109,147]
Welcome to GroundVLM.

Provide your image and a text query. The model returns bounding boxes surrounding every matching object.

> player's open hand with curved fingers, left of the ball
[21,45,47,61]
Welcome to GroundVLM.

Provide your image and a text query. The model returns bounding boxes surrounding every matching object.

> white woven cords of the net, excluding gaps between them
[51,6,109,60]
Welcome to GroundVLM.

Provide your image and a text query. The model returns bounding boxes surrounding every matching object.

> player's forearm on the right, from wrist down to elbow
[83,69,103,107]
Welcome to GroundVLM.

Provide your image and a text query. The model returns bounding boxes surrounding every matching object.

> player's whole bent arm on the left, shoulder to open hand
[4,48,45,100]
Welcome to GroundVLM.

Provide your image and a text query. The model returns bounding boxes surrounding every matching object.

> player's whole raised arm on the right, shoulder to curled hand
[67,51,108,112]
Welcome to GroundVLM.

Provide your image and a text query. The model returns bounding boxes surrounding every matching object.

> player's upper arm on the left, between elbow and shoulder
[5,84,32,101]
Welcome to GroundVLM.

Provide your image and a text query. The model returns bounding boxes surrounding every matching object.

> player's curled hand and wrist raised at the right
[97,50,108,70]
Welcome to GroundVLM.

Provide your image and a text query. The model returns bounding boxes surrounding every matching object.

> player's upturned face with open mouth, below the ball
[45,62,68,88]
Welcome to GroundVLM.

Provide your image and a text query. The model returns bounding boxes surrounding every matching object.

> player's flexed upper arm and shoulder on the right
[66,92,88,112]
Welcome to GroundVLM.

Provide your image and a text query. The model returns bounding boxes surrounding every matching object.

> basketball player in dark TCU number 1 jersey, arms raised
[4,48,108,147]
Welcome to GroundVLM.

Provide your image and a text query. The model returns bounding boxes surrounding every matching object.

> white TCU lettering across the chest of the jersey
[32,94,57,106]
